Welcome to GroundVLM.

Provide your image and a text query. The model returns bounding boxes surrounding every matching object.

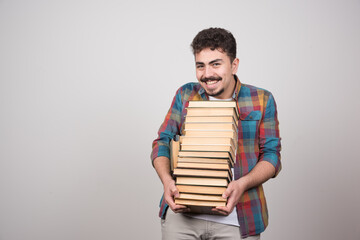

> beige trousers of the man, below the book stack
[161,208,260,240]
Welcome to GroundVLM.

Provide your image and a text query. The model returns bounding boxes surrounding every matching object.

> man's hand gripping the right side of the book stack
[212,178,246,215]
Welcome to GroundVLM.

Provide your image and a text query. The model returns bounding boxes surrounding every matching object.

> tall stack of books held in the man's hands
[171,101,239,214]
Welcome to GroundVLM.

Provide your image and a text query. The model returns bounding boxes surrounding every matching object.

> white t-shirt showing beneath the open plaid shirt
[184,96,240,227]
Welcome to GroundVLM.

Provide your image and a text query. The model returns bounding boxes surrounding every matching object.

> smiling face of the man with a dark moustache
[195,48,239,99]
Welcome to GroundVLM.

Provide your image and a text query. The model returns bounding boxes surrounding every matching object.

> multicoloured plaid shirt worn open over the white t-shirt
[151,76,281,238]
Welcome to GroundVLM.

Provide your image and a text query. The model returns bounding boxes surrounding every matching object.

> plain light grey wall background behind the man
[0,0,360,240]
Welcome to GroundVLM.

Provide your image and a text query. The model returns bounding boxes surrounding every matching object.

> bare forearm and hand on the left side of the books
[154,156,190,213]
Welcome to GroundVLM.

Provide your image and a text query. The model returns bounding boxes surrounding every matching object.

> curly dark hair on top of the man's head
[191,28,236,62]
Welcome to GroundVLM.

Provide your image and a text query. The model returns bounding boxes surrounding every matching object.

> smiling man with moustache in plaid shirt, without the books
[151,28,281,239]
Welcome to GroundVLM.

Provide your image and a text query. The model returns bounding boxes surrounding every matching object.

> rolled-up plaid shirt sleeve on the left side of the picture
[151,88,182,166]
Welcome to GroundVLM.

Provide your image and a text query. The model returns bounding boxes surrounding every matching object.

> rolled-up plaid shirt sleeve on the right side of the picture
[259,93,281,177]
